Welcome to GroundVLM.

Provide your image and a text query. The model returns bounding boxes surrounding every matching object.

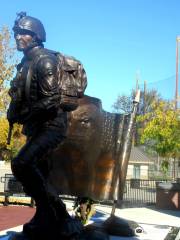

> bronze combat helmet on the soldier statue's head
[13,12,46,42]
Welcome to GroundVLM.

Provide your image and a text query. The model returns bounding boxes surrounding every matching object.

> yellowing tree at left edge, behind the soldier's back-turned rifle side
[0,27,24,160]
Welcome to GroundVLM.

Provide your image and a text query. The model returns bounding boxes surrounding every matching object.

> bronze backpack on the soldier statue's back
[56,53,87,111]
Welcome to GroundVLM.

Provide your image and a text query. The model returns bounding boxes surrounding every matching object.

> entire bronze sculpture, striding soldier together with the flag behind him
[7,13,137,240]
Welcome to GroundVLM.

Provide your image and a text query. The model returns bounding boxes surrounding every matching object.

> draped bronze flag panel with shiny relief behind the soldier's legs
[48,93,137,200]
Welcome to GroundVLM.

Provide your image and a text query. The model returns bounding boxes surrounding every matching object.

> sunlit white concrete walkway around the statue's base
[0,201,180,240]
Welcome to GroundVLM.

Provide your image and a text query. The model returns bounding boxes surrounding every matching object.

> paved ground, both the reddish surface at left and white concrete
[0,202,180,240]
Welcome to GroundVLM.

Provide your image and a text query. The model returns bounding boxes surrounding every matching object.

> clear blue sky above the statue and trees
[0,0,180,111]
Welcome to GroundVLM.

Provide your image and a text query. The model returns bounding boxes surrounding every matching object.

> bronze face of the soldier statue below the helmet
[14,33,33,51]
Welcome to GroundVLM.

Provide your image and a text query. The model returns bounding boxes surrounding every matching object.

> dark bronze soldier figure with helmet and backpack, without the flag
[7,12,97,240]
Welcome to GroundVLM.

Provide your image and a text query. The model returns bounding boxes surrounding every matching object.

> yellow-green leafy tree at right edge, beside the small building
[138,101,180,177]
